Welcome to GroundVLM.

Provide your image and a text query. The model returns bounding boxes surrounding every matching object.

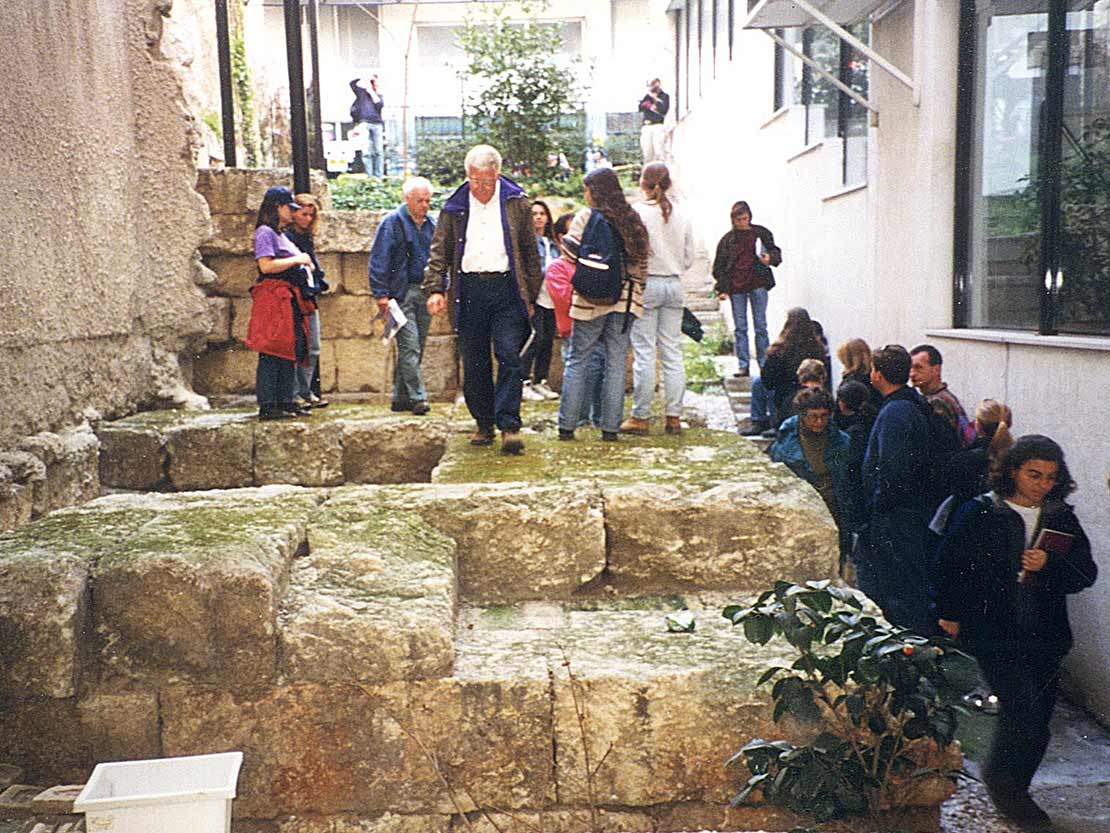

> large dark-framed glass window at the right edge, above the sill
[956,0,1110,334]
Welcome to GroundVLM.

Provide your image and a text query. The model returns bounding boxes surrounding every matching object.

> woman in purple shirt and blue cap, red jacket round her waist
[246,185,313,420]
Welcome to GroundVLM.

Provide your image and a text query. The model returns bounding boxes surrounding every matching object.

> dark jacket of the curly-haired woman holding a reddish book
[937,493,1098,655]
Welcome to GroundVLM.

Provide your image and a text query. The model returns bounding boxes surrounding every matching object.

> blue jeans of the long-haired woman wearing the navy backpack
[558,312,628,433]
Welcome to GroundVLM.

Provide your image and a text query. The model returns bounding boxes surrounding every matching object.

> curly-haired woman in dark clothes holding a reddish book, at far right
[937,434,1098,829]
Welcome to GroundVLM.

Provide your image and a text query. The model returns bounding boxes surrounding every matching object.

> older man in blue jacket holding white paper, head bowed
[370,177,435,417]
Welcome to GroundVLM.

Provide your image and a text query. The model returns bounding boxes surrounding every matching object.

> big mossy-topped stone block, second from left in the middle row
[92,486,316,689]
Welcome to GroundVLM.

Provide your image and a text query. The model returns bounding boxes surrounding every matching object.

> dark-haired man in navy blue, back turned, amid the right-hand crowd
[855,344,937,636]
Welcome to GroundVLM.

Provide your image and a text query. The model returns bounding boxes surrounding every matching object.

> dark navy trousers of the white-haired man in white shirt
[458,274,528,431]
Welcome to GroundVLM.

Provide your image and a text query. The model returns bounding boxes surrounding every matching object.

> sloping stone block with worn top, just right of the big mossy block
[279,504,455,683]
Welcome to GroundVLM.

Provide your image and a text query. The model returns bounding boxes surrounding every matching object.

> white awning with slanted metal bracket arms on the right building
[744,0,925,102]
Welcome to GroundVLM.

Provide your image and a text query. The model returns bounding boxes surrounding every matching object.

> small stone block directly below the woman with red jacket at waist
[254,419,343,486]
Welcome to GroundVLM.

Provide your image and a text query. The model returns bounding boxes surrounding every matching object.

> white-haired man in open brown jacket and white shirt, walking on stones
[424,144,543,454]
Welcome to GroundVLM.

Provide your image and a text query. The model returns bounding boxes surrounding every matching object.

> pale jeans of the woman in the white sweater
[632,274,686,420]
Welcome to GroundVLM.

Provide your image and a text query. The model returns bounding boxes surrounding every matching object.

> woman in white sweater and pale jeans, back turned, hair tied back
[620,162,694,434]
